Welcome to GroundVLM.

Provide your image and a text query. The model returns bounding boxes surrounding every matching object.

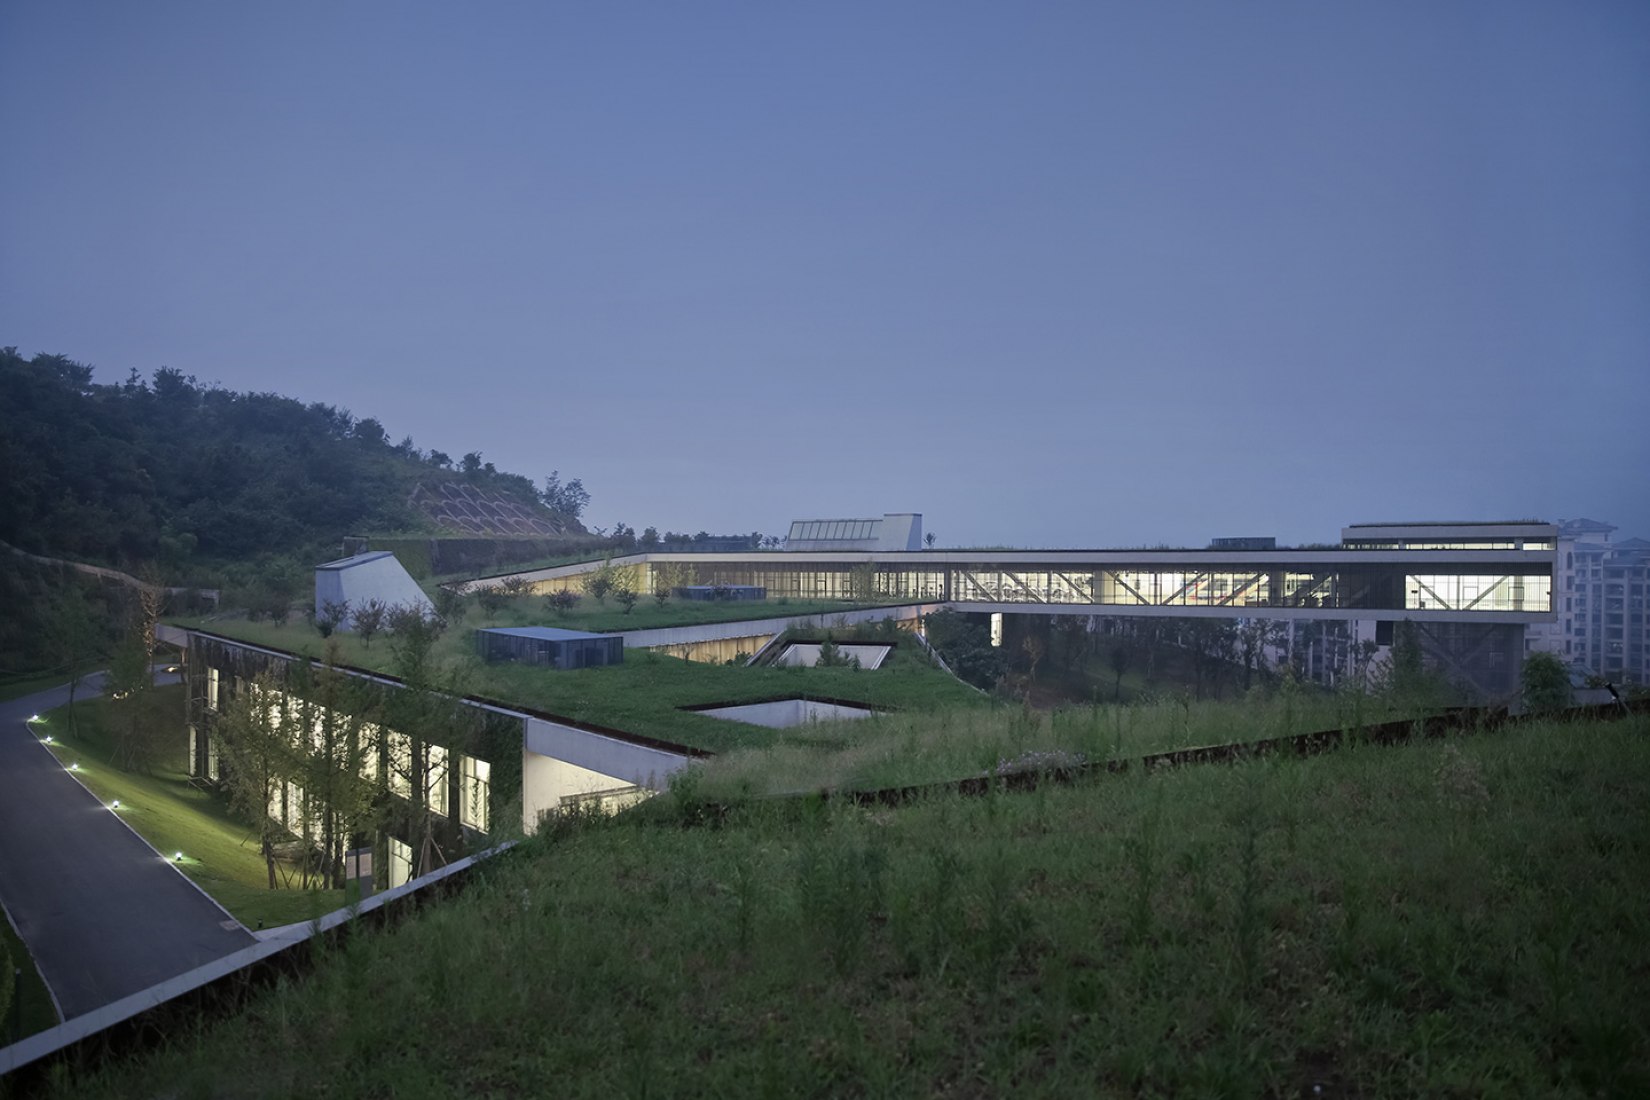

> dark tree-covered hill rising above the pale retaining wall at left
[0,348,584,576]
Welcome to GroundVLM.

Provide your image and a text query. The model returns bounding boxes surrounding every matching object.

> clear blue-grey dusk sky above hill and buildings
[0,0,1650,546]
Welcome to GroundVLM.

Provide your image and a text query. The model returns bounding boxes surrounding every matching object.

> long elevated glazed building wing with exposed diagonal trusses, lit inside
[472,523,1558,698]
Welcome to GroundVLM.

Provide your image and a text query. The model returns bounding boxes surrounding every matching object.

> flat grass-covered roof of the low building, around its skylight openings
[167,605,980,752]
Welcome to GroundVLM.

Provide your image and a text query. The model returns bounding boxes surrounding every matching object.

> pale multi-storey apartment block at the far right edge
[1525,519,1650,684]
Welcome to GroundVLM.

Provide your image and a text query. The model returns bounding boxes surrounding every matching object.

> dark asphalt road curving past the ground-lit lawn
[0,678,256,1018]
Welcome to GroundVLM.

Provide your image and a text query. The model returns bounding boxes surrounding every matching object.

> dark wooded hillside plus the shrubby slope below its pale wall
[0,348,587,683]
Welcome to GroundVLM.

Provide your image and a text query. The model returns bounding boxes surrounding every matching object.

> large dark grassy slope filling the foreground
[64,719,1650,1097]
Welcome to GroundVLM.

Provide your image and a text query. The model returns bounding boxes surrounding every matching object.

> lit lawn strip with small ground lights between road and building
[35,686,345,928]
